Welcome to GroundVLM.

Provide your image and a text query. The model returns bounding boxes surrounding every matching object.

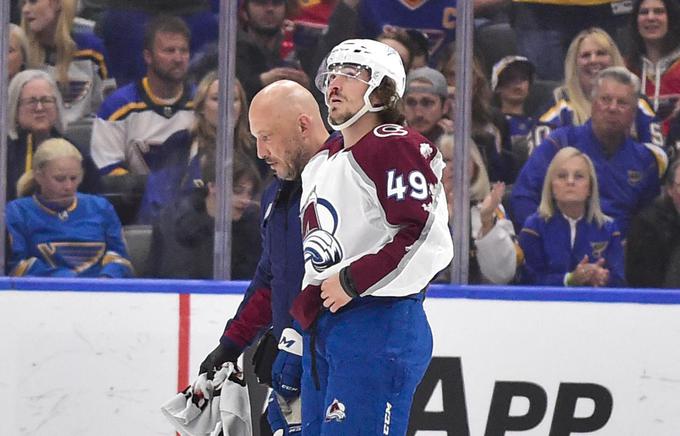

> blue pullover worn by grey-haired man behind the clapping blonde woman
[510,121,668,235]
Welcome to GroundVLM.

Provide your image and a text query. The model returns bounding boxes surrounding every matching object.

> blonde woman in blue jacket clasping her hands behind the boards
[519,147,624,287]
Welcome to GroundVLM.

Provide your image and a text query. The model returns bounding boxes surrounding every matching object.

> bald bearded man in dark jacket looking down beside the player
[200,80,328,433]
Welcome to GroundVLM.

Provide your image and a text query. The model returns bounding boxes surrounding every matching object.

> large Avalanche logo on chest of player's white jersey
[302,188,342,272]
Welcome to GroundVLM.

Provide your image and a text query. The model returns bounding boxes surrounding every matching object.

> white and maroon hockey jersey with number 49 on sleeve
[300,124,453,297]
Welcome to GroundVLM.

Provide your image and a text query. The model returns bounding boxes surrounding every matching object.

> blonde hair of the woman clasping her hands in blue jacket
[538,147,610,227]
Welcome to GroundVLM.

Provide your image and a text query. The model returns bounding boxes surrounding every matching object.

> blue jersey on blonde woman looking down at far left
[6,193,132,277]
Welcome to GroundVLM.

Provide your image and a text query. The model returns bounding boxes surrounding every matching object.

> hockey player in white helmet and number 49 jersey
[291,39,453,436]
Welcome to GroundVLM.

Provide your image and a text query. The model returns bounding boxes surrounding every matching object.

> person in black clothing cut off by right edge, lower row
[626,159,680,289]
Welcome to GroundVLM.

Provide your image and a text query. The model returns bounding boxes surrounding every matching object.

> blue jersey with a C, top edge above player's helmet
[359,0,456,60]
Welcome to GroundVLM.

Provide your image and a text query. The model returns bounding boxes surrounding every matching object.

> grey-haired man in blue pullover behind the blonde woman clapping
[511,67,668,235]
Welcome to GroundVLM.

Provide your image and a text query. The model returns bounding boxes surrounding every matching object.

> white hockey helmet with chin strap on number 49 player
[315,39,406,130]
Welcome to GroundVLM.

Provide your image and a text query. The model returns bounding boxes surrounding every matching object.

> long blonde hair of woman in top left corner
[21,0,77,89]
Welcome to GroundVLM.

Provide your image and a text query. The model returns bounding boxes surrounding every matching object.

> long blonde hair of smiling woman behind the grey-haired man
[555,27,624,126]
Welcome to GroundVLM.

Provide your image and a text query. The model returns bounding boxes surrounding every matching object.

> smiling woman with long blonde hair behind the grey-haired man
[532,28,663,150]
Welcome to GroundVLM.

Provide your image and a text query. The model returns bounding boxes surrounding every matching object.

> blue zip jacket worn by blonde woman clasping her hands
[519,211,624,286]
